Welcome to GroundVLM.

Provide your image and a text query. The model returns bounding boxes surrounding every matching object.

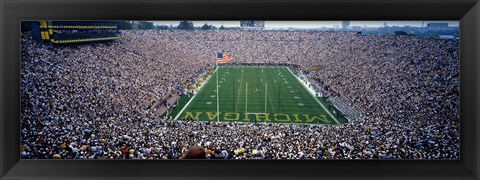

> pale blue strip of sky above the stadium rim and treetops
[153,21,459,29]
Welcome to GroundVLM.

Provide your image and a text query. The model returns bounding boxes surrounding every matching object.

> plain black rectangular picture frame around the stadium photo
[0,0,480,180]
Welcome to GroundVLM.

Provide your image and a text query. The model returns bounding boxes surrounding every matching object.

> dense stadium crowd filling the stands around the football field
[20,30,460,159]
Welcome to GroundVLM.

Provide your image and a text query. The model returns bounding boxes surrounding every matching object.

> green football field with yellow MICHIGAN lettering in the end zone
[172,66,347,124]
